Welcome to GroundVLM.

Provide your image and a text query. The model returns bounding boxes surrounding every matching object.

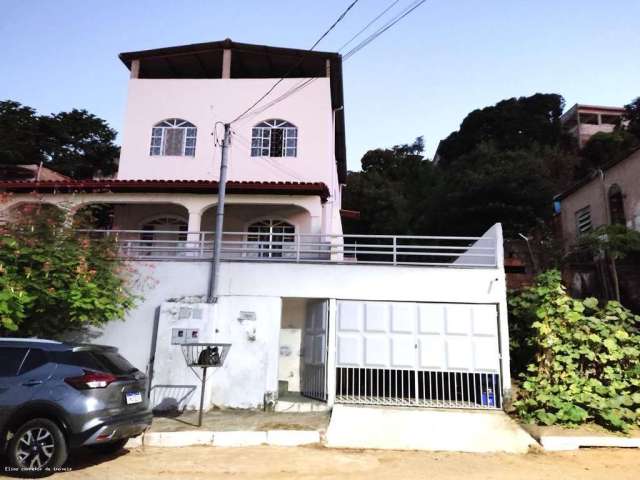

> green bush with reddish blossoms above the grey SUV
[0,204,136,338]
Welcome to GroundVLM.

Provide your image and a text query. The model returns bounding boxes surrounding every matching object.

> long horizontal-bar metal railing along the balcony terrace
[80,230,498,268]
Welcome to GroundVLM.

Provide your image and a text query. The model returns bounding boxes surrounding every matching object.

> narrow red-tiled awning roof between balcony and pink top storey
[0,180,329,202]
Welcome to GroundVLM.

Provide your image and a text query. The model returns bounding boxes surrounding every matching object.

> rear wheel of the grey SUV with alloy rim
[8,418,68,476]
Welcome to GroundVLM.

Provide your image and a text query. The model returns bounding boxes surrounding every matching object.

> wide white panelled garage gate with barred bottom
[336,301,502,408]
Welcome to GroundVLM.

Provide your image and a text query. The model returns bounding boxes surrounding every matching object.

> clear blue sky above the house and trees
[0,0,640,170]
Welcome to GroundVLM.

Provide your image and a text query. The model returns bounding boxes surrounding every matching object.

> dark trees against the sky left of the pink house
[0,100,120,179]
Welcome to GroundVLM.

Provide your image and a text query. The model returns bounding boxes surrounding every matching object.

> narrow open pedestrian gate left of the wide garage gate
[300,300,329,401]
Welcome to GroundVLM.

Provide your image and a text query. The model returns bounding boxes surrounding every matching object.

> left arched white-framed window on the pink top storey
[149,118,197,157]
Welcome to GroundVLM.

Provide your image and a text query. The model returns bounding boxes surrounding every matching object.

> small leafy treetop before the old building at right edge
[577,225,640,260]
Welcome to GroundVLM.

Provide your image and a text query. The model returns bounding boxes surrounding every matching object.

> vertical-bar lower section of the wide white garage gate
[336,367,502,409]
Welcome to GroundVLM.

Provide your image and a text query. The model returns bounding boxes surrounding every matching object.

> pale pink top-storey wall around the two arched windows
[118,78,337,194]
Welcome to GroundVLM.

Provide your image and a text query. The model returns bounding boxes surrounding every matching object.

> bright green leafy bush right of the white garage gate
[509,270,640,431]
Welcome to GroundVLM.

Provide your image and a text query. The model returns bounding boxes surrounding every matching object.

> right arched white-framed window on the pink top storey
[251,119,298,157]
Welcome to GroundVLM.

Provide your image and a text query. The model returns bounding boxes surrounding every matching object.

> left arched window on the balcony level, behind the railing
[140,215,187,257]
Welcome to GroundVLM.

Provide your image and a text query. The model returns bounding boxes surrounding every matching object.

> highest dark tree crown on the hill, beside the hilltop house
[438,93,570,167]
